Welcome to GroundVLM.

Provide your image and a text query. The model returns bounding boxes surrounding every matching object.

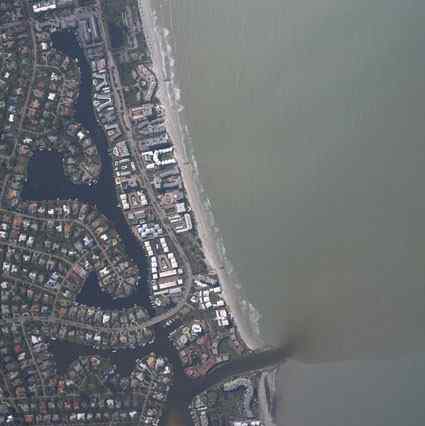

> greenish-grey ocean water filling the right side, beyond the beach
[154,0,425,426]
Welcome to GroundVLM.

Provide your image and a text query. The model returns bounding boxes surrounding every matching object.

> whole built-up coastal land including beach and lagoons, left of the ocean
[0,0,285,426]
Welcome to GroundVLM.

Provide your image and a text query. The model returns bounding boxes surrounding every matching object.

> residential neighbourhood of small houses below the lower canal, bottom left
[0,316,174,426]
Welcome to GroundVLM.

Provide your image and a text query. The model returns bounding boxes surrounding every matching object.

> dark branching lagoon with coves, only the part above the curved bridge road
[22,31,153,314]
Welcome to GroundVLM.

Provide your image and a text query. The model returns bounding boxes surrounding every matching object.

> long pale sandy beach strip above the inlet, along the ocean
[138,0,264,349]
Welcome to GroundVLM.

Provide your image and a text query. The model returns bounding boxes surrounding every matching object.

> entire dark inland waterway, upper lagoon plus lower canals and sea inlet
[23,31,284,425]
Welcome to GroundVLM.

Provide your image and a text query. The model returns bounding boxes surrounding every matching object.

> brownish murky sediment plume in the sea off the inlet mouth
[280,247,425,362]
